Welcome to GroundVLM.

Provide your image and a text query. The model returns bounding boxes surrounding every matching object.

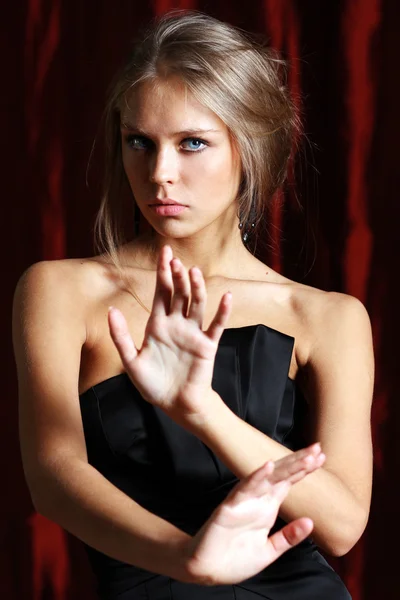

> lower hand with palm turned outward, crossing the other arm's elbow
[185,444,325,585]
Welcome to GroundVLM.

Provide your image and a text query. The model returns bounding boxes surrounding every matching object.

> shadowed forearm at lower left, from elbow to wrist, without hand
[32,460,191,581]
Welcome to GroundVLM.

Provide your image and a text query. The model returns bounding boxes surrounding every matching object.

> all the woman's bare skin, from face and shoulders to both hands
[14,76,373,584]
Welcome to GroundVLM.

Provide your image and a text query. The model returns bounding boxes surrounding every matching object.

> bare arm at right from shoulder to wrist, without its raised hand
[188,294,374,556]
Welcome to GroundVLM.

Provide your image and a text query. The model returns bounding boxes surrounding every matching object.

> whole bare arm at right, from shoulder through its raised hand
[109,245,374,556]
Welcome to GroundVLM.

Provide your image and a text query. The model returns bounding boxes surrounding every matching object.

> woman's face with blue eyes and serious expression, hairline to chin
[121,79,240,238]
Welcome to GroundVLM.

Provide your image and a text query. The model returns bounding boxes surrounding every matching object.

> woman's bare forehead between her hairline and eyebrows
[121,78,227,133]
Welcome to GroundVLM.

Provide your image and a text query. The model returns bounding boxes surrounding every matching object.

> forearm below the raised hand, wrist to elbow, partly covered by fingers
[189,394,367,555]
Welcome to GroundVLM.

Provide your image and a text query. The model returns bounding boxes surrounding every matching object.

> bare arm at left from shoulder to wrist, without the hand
[13,261,190,581]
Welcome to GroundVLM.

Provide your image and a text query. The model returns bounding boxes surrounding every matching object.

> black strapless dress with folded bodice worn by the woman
[80,325,351,600]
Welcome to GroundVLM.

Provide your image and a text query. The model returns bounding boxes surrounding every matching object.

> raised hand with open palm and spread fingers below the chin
[109,245,231,424]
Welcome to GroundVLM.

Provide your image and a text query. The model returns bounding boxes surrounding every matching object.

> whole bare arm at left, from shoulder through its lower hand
[13,261,325,585]
